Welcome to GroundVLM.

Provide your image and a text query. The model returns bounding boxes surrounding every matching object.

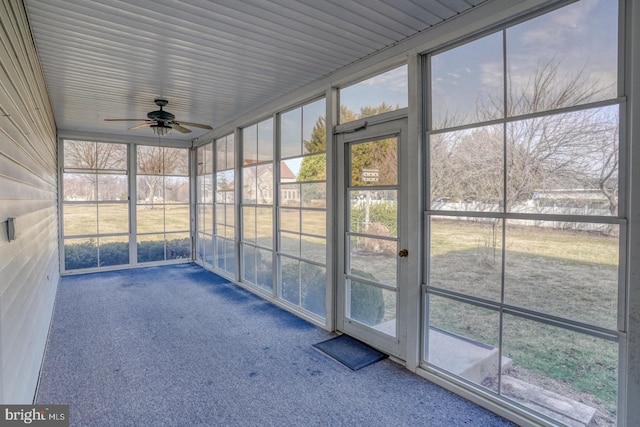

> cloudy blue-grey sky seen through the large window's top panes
[432,0,618,124]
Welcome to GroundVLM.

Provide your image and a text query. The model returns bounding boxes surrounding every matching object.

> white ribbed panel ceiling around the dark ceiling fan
[24,0,485,140]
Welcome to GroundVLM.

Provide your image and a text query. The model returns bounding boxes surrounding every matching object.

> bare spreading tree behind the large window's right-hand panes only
[500,59,618,214]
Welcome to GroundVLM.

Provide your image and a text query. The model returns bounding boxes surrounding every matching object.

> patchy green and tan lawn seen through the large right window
[430,218,618,424]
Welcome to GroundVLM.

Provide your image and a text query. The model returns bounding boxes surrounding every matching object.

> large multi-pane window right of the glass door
[423,1,624,425]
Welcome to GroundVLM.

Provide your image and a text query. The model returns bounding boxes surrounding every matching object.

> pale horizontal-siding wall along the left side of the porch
[0,0,60,403]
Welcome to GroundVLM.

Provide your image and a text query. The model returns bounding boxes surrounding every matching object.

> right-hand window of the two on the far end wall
[136,146,191,263]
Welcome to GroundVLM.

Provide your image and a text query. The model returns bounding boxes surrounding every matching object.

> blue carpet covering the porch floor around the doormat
[36,264,512,426]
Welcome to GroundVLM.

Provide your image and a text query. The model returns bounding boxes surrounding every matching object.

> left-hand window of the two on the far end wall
[62,140,129,271]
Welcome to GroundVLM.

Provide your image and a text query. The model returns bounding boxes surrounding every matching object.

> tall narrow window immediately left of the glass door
[278,99,327,317]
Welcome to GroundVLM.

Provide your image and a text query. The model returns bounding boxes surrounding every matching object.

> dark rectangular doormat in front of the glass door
[313,334,389,371]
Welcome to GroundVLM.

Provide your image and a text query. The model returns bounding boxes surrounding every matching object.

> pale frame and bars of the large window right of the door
[419,0,631,420]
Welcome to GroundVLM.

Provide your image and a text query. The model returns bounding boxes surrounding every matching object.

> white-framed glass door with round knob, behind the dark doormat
[338,119,406,356]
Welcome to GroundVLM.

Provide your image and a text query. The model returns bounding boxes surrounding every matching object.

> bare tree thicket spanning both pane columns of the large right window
[430,60,618,215]
